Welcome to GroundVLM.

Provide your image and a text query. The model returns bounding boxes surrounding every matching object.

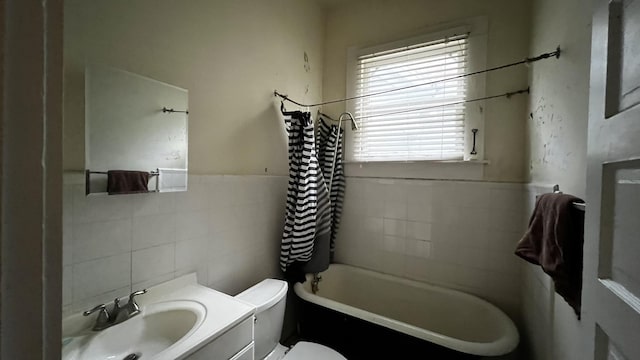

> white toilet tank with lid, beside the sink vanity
[236,279,288,360]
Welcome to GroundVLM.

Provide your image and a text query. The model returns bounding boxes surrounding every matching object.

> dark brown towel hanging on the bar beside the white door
[515,193,584,319]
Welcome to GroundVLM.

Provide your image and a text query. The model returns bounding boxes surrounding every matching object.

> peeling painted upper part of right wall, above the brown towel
[527,0,591,196]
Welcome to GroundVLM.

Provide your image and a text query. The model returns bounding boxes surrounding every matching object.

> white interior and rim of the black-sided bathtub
[294,264,519,356]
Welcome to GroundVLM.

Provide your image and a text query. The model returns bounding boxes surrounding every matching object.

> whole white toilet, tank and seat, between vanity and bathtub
[236,279,346,360]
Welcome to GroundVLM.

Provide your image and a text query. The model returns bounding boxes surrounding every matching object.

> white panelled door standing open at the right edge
[584,0,640,360]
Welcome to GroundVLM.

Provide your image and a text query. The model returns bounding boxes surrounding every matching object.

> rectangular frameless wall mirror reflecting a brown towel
[85,65,189,195]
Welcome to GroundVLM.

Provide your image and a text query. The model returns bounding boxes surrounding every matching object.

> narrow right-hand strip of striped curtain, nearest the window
[317,118,345,255]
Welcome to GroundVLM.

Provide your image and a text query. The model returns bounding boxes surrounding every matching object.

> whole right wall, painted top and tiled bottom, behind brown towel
[521,0,592,360]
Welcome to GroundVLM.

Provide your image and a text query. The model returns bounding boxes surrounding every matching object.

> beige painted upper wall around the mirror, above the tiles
[64,0,324,175]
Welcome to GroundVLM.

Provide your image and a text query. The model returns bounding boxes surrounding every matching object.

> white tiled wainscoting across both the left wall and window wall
[63,175,525,330]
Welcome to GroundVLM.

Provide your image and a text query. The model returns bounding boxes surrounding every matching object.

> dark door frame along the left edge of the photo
[0,0,63,359]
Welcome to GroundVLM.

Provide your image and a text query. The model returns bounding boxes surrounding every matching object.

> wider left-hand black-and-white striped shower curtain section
[280,111,330,276]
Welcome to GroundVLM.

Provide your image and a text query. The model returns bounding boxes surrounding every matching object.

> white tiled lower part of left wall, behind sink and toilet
[63,175,287,314]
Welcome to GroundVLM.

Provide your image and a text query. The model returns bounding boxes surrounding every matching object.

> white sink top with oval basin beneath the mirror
[62,273,254,360]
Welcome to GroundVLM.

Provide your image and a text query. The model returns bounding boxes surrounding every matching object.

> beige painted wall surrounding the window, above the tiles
[322,0,528,182]
